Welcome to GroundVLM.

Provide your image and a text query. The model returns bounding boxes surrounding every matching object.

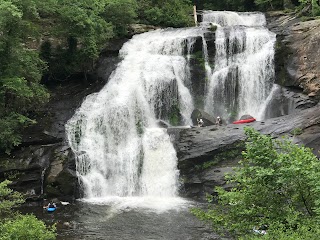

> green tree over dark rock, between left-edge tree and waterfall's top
[42,0,114,80]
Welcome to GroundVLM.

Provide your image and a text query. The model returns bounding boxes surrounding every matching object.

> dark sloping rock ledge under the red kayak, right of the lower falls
[168,104,320,200]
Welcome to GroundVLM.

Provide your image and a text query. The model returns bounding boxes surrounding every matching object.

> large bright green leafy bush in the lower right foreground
[193,128,320,239]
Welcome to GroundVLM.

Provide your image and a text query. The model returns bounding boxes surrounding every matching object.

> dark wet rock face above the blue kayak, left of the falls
[0,143,77,201]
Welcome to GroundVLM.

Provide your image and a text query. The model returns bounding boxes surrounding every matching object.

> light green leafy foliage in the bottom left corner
[0,180,56,240]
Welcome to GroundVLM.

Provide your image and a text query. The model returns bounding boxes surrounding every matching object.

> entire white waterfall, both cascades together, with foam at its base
[66,12,275,211]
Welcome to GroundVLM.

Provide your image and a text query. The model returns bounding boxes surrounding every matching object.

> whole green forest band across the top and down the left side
[0,0,320,153]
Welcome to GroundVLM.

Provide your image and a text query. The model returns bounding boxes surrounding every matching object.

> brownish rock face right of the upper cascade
[268,13,320,99]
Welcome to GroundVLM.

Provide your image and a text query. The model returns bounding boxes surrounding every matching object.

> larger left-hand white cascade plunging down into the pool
[66,28,201,207]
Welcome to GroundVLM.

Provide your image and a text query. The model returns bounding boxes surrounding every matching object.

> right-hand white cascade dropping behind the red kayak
[202,11,276,120]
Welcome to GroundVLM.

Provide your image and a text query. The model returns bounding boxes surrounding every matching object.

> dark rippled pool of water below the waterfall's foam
[24,202,225,240]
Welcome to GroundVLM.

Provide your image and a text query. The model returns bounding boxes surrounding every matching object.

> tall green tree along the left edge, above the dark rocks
[0,0,49,152]
